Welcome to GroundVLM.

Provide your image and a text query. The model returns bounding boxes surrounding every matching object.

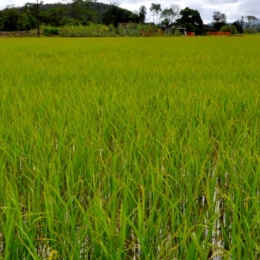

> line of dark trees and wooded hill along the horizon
[0,0,260,34]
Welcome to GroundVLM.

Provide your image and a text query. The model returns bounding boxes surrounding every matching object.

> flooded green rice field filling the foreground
[0,37,260,260]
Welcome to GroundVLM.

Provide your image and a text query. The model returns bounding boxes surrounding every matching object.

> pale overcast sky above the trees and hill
[0,0,260,23]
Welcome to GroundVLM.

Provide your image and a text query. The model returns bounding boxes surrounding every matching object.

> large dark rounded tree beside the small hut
[176,7,203,34]
